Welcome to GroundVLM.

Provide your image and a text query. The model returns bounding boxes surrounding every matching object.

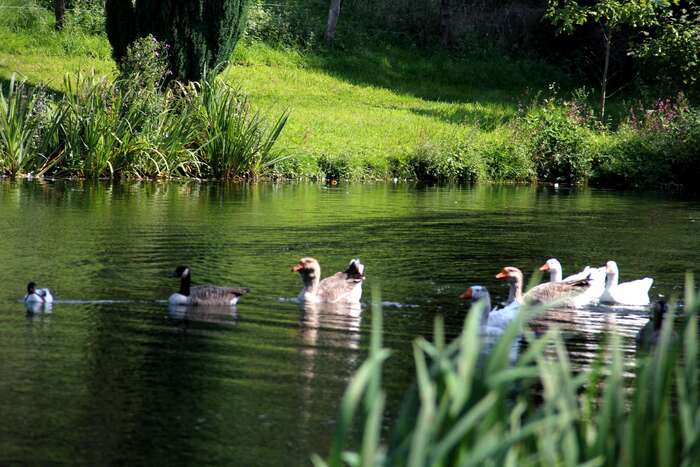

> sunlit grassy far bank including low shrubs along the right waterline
[0,0,700,186]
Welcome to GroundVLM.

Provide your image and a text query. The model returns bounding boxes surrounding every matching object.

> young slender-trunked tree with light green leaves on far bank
[546,0,677,117]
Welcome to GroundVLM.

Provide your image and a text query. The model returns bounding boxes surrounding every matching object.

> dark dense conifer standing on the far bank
[105,0,248,81]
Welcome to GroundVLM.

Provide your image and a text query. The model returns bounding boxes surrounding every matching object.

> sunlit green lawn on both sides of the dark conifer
[0,5,565,176]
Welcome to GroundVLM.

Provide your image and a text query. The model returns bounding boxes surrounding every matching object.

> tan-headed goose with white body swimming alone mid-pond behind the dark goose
[292,256,365,303]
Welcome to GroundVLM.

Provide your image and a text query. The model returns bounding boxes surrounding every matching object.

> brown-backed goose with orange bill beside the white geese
[496,266,604,308]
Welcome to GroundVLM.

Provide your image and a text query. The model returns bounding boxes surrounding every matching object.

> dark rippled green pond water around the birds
[0,181,700,466]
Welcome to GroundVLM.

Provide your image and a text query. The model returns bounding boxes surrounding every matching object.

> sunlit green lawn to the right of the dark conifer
[223,43,561,166]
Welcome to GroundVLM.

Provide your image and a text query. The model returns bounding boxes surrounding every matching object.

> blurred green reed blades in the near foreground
[313,281,700,467]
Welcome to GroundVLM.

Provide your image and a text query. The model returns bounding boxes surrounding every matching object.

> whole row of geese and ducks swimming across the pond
[24,257,654,333]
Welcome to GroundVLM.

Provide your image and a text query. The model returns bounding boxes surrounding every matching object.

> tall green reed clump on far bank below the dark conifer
[0,73,288,179]
